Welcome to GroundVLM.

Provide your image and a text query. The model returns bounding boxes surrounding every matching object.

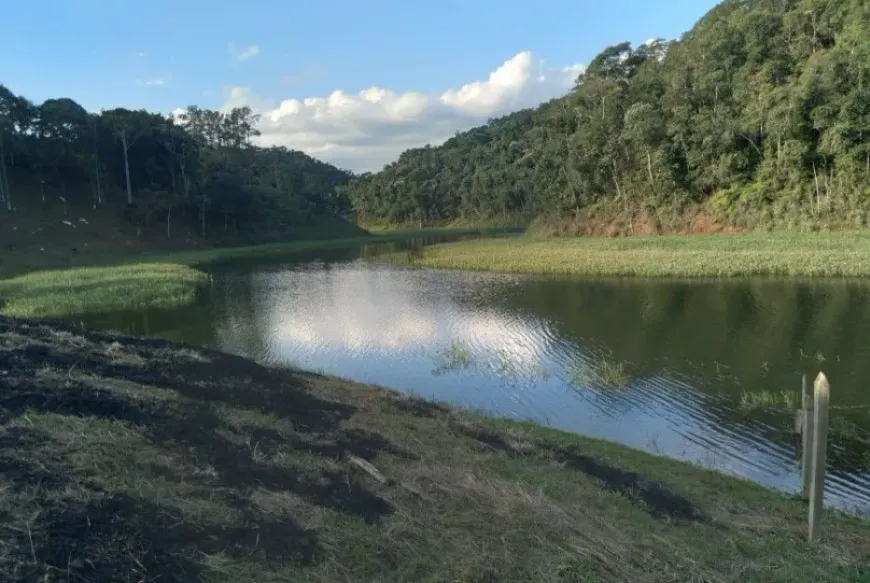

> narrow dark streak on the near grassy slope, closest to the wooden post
[451,424,709,522]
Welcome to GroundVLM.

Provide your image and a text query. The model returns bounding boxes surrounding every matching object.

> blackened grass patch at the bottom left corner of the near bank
[7,494,320,583]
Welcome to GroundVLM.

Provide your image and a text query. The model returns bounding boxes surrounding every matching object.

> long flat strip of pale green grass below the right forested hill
[397,231,870,277]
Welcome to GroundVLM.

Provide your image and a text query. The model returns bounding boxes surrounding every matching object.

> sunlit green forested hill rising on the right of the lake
[347,0,870,232]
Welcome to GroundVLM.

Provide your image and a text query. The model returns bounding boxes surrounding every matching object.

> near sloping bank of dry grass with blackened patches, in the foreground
[0,318,870,583]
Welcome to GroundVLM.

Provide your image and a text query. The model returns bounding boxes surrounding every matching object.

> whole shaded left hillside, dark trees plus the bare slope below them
[0,85,363,268]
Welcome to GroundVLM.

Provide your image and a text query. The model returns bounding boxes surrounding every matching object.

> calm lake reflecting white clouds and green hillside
[75,237,870,514]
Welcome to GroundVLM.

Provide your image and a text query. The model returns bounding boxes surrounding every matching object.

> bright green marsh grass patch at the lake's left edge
[0,263,208,317]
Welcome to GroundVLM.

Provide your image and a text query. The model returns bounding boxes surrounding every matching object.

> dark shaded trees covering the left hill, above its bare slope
[0,85,350,239]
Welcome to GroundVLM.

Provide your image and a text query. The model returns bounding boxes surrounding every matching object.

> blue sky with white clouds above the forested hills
[0,0,715,167]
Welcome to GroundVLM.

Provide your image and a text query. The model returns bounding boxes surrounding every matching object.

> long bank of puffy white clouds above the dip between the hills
[222,51,583,171]
